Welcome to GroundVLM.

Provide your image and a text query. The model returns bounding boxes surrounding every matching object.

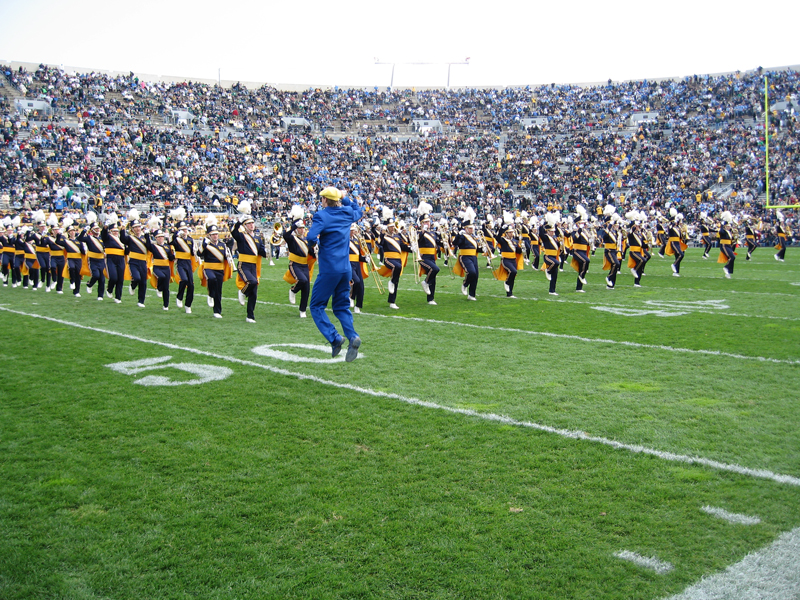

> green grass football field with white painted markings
[0,248,800,600]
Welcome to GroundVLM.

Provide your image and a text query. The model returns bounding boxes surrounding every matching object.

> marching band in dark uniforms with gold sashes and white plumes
[0,200,791,323]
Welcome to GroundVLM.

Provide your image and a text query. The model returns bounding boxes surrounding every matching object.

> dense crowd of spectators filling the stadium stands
[0,65,800,234]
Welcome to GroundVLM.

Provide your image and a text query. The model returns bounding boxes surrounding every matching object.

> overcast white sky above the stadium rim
[0,0,800,87]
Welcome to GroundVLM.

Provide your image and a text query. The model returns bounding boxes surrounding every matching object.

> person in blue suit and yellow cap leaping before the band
[307,187,364,362]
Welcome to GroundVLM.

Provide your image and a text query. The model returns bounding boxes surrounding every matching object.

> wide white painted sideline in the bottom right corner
[668,527,800,600]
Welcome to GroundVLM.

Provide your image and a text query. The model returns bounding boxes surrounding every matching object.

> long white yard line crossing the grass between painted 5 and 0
[0,307,800,487]
